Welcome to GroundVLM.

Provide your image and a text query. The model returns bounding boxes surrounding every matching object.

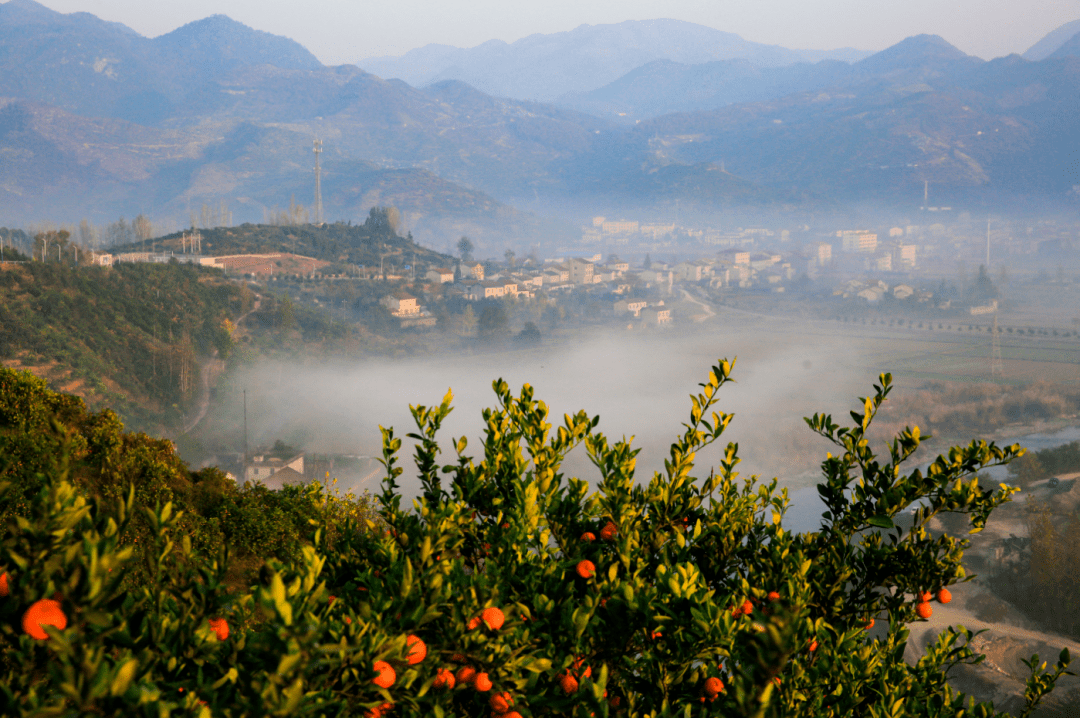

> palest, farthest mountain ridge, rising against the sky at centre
[357,19,870,101]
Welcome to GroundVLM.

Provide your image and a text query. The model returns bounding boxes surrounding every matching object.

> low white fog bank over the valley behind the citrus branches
[233,327,888,530]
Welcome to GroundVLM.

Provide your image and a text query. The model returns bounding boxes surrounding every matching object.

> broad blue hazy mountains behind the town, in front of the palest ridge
[0,0,1080,236]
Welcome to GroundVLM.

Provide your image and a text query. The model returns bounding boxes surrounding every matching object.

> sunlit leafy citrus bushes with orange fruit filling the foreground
[0,362,1069,718]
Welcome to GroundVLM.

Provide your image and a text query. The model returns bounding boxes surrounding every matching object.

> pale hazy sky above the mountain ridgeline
[21,0,1080,65]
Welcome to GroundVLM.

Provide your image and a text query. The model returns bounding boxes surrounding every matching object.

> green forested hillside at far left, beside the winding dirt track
[0,261,240,423]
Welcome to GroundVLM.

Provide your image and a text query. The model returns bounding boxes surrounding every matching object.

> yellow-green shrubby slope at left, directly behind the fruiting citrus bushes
[0,368,374,590]
